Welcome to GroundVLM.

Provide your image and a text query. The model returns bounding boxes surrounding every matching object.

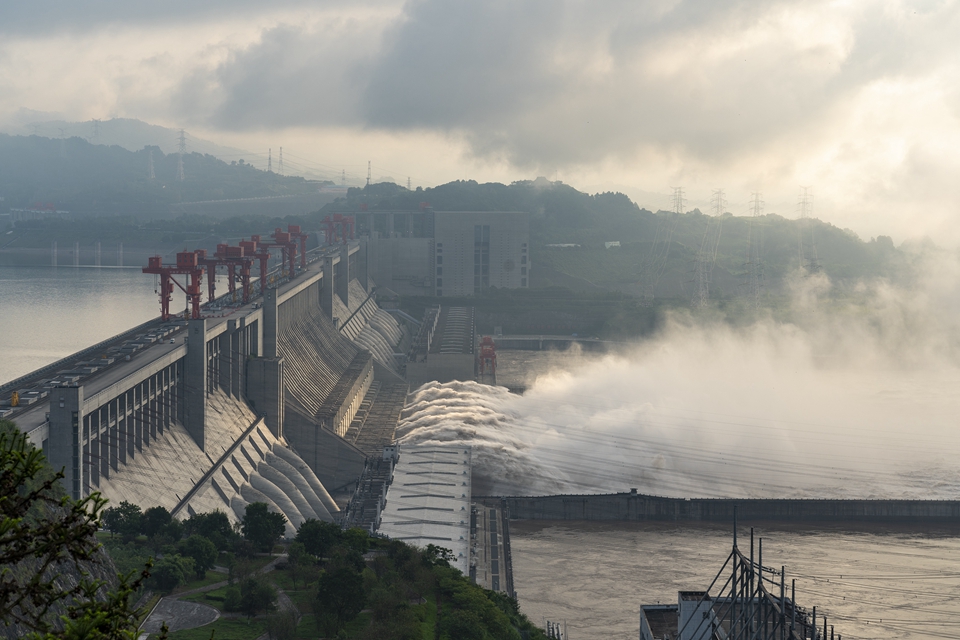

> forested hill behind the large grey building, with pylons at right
[321,178,912,298]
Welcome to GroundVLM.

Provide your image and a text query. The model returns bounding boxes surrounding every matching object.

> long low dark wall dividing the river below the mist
[502,492,960,524]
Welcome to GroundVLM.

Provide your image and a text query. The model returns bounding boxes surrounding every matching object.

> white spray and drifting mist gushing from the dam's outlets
[398,262,960,499]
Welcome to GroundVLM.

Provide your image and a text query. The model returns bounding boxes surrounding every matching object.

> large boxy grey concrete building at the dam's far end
[354,207,531,297]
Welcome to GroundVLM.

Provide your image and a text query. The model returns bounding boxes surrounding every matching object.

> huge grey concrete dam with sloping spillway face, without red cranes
[0,242,409,534]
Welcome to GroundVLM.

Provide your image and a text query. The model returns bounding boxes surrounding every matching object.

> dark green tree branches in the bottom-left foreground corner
[0,420,149,640]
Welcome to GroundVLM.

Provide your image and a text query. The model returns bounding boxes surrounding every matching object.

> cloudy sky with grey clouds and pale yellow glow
[0,0,960,247]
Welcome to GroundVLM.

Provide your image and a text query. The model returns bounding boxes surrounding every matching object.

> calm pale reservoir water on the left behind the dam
[0,267,163,384]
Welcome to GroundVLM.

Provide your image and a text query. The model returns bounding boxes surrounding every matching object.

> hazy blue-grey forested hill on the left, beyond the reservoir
[0,134,330,219]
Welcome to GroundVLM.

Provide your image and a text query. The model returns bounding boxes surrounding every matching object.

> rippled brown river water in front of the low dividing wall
[510,521,960,640]
